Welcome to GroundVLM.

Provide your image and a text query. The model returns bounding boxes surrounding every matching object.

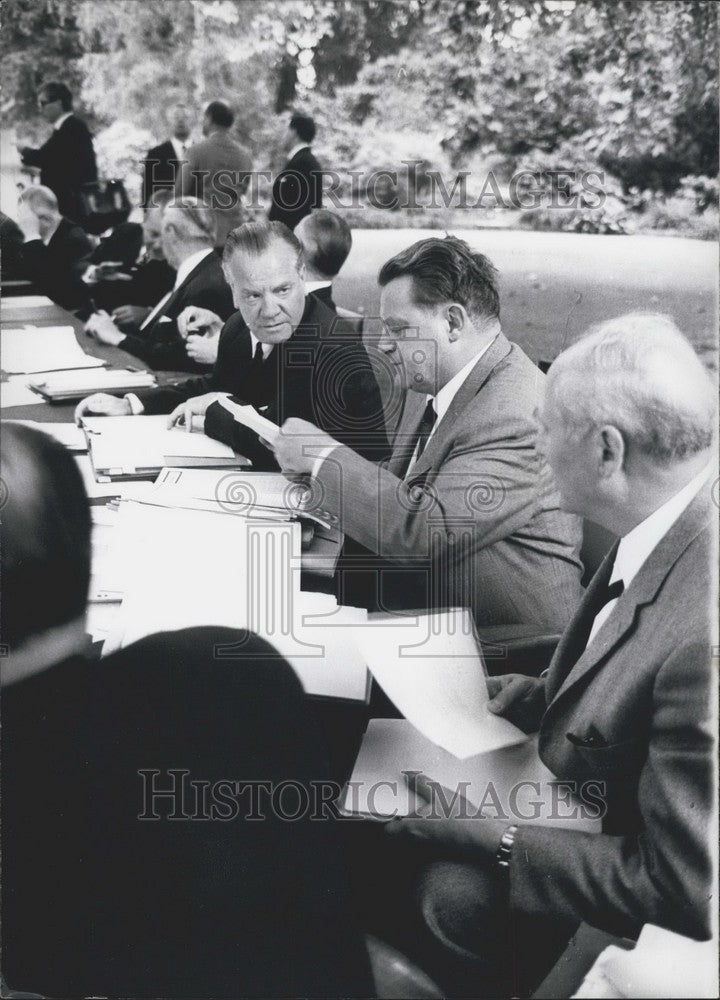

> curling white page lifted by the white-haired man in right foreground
[355,608,525,758]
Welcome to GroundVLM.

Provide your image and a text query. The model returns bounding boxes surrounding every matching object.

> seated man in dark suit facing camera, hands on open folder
[77,223,388,469]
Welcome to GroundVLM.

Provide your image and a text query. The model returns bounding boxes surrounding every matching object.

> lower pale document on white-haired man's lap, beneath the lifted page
[341,719,603,833]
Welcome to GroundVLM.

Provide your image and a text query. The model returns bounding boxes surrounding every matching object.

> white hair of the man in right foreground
[547,312,715,464]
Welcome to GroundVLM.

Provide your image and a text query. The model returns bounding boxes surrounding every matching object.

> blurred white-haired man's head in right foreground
[540,313,715,534]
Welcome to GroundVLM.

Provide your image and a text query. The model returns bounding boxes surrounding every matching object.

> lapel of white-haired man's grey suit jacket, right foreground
[547,483,711,711]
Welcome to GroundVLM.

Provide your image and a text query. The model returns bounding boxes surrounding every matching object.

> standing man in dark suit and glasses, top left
[20,82,97,225]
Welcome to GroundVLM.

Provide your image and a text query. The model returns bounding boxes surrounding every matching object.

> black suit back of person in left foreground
[0,628,372,997]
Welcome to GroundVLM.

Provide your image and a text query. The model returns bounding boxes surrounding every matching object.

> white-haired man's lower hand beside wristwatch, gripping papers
[385,772,512,863]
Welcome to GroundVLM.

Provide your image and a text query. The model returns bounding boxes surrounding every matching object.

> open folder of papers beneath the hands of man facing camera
[83,416,249,481]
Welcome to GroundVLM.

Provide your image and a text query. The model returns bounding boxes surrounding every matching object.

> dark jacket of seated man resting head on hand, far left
[23,219,93,311]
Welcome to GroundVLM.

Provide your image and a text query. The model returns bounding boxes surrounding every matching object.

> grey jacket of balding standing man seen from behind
[175,132,252,247]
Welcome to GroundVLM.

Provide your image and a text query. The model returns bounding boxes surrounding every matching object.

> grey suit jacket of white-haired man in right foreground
[510,485,717,938]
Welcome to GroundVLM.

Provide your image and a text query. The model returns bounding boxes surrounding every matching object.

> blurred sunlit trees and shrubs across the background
[0,0,718,238]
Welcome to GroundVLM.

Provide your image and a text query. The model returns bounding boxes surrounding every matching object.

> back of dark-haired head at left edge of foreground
[0,424,90,649]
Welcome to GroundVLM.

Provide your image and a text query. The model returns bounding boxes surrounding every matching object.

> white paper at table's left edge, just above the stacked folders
[0,326,105,374]
